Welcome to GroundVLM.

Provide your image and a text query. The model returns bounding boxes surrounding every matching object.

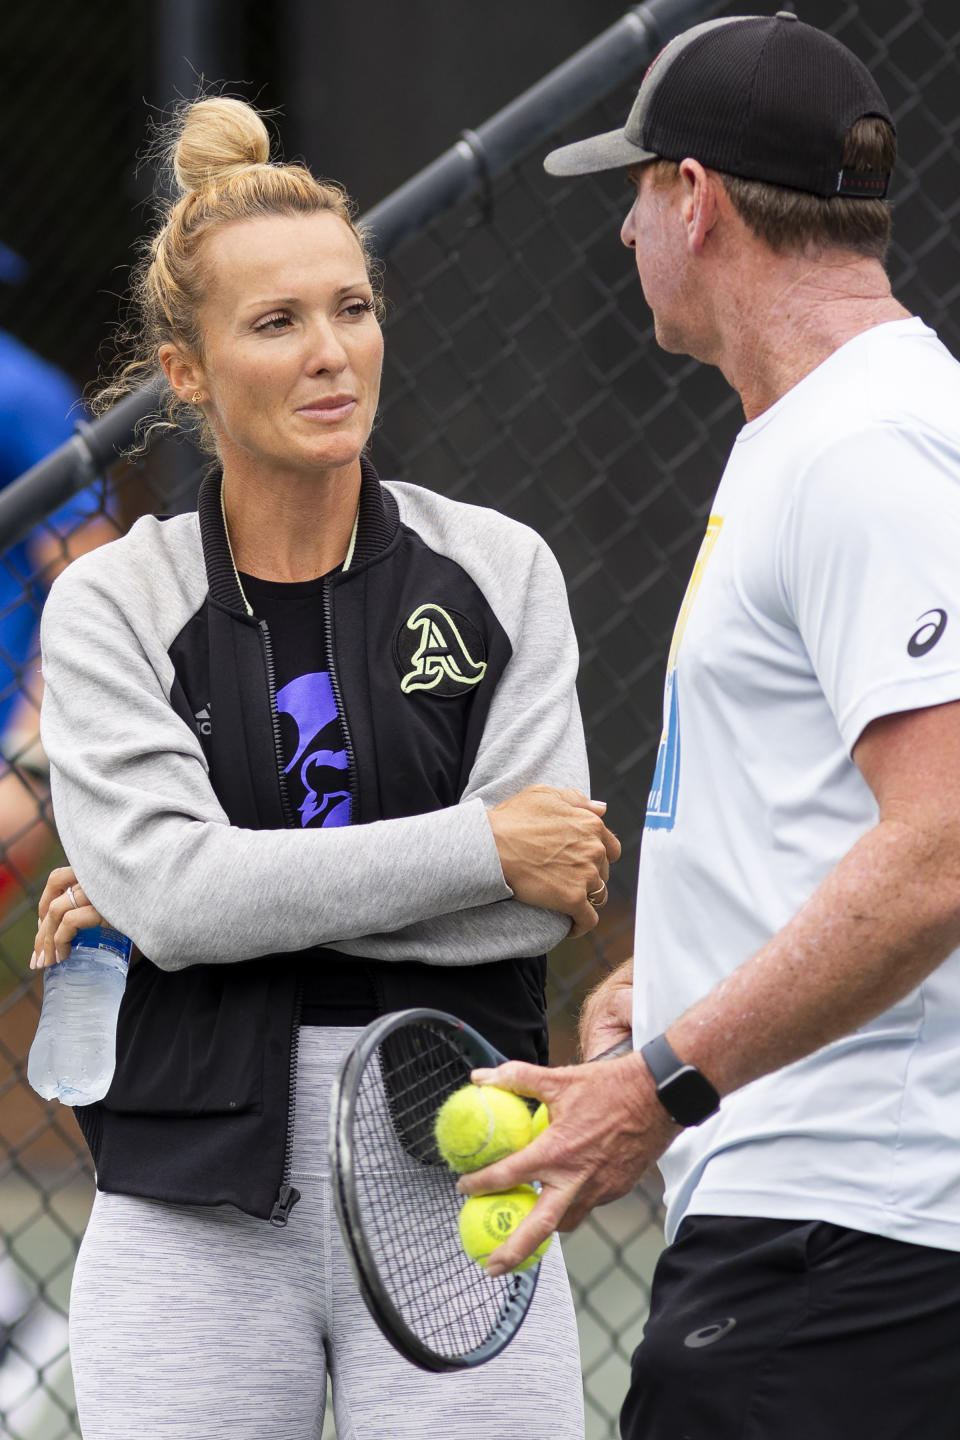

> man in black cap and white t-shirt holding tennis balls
[461,14,960,1440]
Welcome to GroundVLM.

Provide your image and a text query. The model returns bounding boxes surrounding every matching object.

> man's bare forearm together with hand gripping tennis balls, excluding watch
[459,821,960,1273]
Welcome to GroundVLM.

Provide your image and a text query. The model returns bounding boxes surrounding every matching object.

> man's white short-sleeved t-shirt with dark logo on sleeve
[635,320,960,1250]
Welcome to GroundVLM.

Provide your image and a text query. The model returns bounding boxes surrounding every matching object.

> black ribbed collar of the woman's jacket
[197,455,400,615]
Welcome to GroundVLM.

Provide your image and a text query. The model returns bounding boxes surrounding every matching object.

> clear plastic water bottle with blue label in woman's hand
[27,924,131,1104]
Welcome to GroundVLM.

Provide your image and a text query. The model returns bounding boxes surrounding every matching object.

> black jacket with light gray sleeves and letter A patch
[42,462,587,1221]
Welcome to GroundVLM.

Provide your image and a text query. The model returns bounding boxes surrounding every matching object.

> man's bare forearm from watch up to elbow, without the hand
[666,821,960,1094]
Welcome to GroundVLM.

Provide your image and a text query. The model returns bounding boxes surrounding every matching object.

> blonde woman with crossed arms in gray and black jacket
[33,98,619,1440]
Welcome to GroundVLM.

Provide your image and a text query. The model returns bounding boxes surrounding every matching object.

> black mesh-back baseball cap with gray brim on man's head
[544,10,894,199]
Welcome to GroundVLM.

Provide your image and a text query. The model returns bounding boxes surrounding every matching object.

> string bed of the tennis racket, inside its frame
[353,1025,517,1356]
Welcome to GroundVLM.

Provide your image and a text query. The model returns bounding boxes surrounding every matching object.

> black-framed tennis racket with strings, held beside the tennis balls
[330,1009,630,1371]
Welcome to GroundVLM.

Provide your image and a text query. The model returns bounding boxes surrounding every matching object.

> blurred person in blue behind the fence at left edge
[0,243,118,909]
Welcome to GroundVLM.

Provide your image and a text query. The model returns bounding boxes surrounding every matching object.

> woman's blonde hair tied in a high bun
[92,95,380,455]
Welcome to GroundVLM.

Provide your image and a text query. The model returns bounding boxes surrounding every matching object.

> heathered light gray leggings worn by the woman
[71,1027,583,1440]
